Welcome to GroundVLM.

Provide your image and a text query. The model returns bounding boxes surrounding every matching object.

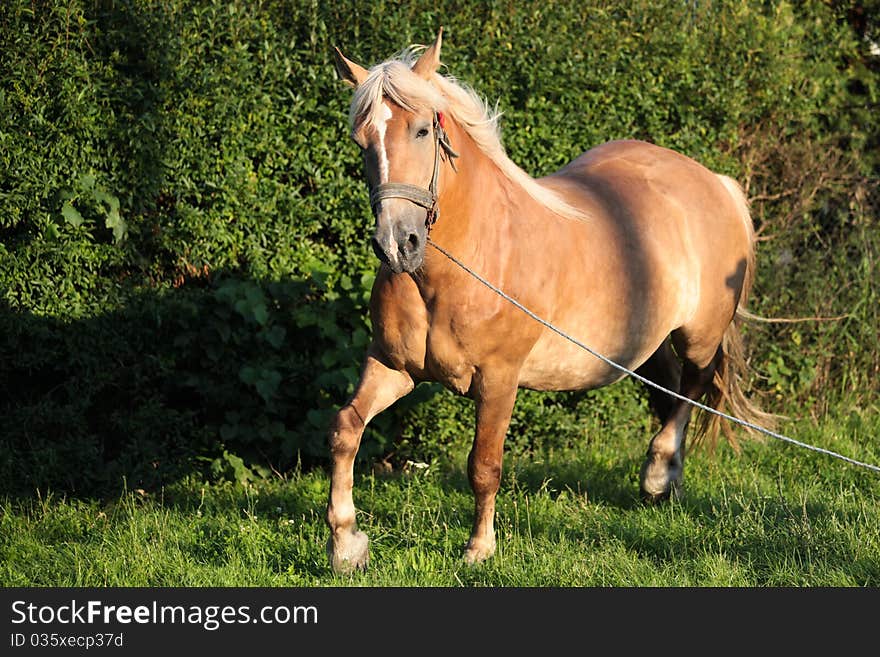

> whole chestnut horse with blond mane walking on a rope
[327,30,760,572]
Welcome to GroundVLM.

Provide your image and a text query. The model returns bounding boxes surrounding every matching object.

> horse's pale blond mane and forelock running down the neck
[349,46,583,218]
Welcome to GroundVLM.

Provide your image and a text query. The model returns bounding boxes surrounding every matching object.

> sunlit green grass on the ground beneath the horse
[0,407,880,587]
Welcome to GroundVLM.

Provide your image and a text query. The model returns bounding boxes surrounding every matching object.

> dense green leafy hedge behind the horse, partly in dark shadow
[0,0,880,492]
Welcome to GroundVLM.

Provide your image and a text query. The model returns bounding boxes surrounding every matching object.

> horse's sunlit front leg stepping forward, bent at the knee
[327,355,414,573]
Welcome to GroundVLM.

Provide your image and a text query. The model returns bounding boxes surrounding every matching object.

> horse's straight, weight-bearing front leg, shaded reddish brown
[464,380,517,564]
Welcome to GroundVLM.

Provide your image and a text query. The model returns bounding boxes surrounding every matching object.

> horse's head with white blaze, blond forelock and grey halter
[334,28,455,273]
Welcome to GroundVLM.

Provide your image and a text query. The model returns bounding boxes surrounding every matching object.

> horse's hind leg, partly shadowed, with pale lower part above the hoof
[640,335,724,502]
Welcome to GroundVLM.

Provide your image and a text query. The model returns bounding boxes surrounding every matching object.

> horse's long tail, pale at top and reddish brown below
[697,175,778,451]
